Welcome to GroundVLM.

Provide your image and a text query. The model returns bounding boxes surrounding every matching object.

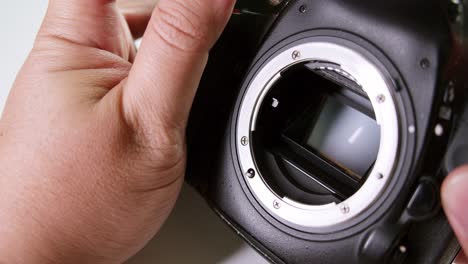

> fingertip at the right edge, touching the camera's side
[442,166,468,252]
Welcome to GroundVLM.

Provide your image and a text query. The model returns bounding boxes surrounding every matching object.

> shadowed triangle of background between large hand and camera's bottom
[127,186,267,264]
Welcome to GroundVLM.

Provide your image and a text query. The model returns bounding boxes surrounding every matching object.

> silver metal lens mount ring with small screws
[236,41,399,228]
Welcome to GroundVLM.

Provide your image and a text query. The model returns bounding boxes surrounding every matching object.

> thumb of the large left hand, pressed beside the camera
[123,0,234,144]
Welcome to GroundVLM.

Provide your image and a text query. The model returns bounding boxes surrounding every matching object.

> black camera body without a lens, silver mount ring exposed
[187,0,468,263]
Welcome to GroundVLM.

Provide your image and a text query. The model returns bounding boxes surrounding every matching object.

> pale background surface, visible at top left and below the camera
[0,0,267,264]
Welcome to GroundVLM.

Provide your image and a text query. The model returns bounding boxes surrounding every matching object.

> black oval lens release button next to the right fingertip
[407,180,439,219]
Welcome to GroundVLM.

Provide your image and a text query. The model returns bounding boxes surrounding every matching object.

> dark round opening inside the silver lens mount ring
[253,62,380,205]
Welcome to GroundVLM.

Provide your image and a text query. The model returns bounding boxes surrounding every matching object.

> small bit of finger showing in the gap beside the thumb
[117,0,158,38]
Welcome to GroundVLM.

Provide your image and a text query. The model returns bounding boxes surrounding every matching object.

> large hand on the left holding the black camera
[0,0,234,263]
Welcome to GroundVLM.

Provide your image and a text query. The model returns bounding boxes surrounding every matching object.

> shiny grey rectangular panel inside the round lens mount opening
[292,97,380,179]
